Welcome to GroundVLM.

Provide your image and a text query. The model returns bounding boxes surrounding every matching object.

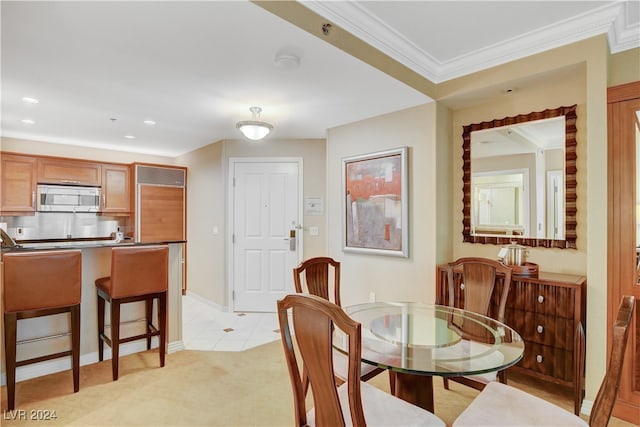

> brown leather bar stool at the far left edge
[3,250,82,410]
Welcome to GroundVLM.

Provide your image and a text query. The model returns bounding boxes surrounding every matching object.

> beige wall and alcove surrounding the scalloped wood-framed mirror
[438,36,617,401]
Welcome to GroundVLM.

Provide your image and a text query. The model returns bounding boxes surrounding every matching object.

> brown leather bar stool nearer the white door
[96,245,169,381]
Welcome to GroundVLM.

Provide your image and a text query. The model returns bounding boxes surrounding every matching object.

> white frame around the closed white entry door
[227,157,304,312]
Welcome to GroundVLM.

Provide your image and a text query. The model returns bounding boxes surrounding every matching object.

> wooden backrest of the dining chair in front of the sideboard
[447,257,511,322]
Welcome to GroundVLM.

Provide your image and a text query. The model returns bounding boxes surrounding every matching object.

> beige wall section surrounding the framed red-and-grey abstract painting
[327,103,438,305]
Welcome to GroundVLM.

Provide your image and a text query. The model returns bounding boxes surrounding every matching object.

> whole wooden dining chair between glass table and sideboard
[440,257,511,390]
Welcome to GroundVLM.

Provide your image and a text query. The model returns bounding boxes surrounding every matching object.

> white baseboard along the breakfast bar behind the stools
[0,337,185,386]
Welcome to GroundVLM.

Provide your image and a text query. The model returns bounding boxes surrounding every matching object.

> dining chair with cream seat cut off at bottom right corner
[453,296,635,427]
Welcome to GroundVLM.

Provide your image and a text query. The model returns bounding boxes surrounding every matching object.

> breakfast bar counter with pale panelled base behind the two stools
[0,240,186,385]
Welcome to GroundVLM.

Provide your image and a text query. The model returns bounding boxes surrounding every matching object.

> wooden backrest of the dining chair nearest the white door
[293,257,341,306]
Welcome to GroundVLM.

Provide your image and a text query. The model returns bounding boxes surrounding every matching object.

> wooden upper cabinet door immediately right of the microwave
[101,164,131,213]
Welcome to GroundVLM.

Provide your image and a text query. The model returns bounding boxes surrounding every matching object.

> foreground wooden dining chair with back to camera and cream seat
[278,294,445,426]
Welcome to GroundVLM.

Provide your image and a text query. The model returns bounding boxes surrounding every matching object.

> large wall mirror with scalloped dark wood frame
[462,105,577,248]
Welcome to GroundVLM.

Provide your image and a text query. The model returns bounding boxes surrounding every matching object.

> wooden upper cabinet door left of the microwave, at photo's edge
[0,154,37,215]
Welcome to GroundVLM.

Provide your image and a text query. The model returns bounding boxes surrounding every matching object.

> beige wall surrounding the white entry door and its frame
[178,139,327,309]
